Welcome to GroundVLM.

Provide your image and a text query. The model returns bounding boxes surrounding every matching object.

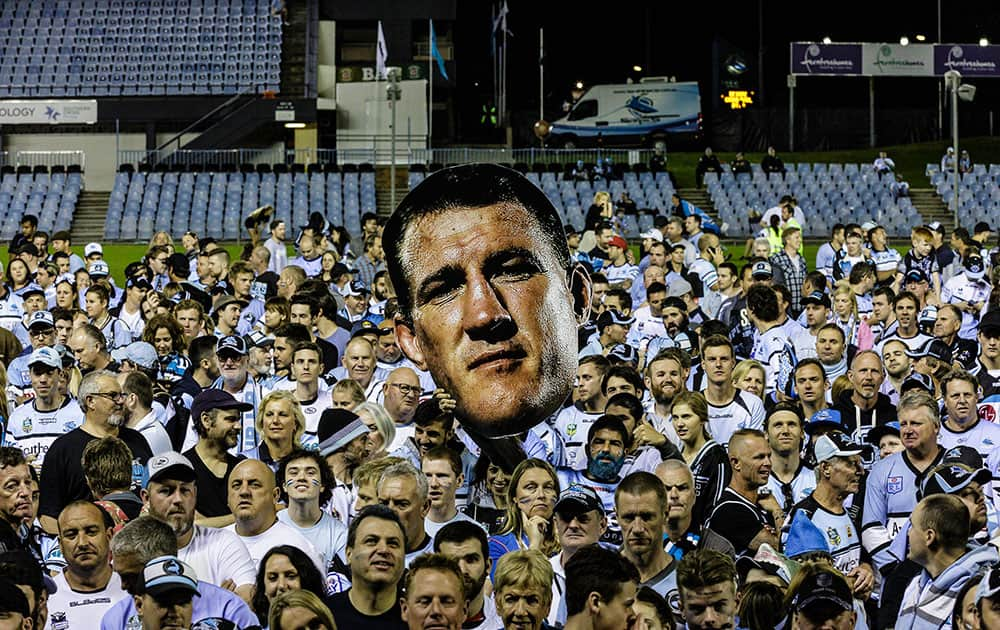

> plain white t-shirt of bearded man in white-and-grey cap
[177,525,257,586]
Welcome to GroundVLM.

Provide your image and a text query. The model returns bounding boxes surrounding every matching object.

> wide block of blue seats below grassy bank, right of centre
[705,162,923,236]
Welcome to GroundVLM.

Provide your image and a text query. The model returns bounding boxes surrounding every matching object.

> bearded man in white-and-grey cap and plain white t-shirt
[142,451,256,603]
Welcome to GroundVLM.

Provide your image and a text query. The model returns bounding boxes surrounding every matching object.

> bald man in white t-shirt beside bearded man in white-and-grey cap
[226,459,326,575]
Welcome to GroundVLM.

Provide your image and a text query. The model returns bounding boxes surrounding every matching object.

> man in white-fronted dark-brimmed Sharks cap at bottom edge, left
[132,556,199,630]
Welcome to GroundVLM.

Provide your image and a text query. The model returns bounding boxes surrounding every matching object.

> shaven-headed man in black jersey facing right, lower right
[707,429,783,556]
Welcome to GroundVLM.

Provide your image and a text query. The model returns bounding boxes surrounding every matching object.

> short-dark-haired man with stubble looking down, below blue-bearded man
[615,472,680,615]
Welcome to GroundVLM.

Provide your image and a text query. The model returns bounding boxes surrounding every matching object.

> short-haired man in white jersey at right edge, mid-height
[938,370,1000,459]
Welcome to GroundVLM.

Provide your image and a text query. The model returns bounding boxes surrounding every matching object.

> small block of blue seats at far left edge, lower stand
[0,167,83,242]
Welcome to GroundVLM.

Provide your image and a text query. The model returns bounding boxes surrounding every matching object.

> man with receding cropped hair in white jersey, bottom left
[48,501,126,628]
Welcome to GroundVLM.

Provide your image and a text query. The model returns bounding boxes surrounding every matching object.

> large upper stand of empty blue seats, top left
[0,0,282,97]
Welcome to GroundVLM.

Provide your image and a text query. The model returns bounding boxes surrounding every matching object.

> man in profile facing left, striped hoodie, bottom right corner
[895,494,1000,628]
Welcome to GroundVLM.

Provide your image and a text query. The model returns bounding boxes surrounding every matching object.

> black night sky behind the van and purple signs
[453,0,1000,119]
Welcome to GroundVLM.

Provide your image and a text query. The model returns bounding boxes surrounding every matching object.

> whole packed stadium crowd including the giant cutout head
[0,163,1000,630]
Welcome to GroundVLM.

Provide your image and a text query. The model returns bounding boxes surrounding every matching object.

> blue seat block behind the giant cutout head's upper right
[409,165,674,238]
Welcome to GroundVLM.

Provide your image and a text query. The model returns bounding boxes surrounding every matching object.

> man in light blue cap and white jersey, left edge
[7,346,83,467]
